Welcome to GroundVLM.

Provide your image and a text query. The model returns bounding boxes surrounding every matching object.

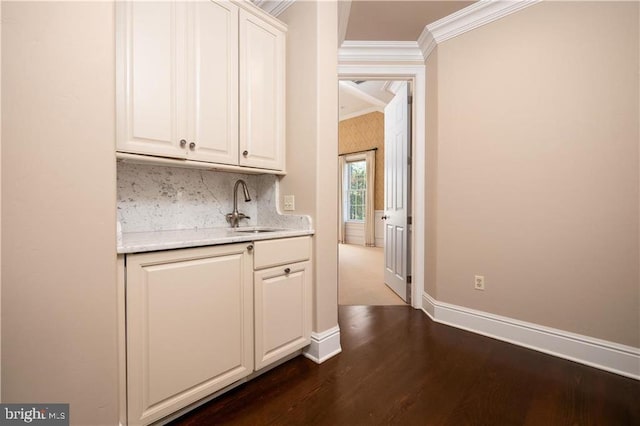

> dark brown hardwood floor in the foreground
[172,306,640,426]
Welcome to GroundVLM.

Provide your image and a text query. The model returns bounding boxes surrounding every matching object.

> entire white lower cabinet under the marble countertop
[122,237,312,425]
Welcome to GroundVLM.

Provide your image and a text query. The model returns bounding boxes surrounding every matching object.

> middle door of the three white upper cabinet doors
[187,1,238,164]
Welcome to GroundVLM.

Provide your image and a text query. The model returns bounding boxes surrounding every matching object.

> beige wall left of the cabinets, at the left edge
[1,2,118,425]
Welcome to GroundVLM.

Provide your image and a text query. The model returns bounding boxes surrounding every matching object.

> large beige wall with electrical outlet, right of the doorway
[427,2,640,347]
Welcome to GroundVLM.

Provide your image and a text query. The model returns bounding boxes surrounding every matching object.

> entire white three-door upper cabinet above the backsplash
[116,1,286,171]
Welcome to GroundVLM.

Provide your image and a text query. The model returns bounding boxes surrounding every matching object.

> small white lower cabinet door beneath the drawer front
[254,262,312,370]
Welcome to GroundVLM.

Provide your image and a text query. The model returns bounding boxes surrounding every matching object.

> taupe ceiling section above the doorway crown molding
[345,0,474,41]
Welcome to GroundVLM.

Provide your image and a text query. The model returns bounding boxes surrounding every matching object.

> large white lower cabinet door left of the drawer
[126,244,253,425]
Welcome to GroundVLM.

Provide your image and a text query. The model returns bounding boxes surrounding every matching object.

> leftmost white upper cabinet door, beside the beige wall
[116,2,186,158]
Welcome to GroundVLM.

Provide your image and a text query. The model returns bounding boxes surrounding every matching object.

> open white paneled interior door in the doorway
[383,83,411,303]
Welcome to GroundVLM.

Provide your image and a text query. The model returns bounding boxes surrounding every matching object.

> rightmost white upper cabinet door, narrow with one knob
[240,10,285,170]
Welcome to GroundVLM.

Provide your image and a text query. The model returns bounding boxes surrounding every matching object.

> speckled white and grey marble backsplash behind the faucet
[117,162,311,232]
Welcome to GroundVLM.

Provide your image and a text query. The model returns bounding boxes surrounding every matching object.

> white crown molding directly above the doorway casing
[338,40,424,63]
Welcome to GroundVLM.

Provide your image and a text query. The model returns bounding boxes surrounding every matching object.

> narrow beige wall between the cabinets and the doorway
[279,1,338,331]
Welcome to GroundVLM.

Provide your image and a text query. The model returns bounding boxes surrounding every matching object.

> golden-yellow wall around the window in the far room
[338,112,384,210]
